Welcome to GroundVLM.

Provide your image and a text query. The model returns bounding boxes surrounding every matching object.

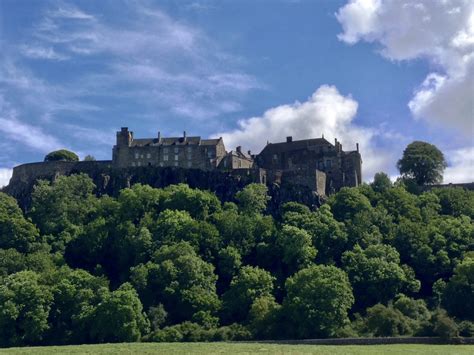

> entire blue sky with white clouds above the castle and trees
[0,0,474,186]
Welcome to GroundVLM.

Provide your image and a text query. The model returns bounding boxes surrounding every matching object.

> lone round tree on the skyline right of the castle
[397,141,447,185]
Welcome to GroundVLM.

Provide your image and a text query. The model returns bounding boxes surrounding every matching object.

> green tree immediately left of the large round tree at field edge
[222,266,275,323]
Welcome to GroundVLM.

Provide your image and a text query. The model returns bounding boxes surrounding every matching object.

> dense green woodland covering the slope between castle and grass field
[0,173,474,347]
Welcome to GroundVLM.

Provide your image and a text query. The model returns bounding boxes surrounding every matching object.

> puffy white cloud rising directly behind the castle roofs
[217,85,390,178]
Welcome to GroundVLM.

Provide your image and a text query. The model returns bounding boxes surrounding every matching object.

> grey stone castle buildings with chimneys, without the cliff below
[112,127,362,196]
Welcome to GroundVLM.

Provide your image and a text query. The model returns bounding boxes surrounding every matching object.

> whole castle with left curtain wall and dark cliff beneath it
[2,127,362,213]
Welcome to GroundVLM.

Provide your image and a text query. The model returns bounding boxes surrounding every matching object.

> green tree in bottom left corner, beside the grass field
[0,271,52,347]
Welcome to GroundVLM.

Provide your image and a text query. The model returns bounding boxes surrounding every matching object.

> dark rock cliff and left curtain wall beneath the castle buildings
[3,160,320,213]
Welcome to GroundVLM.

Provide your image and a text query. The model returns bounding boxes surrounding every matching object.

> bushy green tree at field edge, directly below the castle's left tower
[90,283,150,343]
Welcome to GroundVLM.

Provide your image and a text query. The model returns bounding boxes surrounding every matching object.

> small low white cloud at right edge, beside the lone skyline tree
[443,147,474,183]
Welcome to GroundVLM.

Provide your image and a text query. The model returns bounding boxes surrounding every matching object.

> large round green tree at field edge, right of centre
[283,265,354,338]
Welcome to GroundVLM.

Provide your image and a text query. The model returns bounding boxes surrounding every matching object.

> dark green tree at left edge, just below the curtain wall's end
[0,192,41,253]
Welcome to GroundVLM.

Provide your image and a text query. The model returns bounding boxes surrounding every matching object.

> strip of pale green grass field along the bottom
[0,343,474,355]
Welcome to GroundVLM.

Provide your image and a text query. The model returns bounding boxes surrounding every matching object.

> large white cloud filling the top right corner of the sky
[336,0,474,136]
